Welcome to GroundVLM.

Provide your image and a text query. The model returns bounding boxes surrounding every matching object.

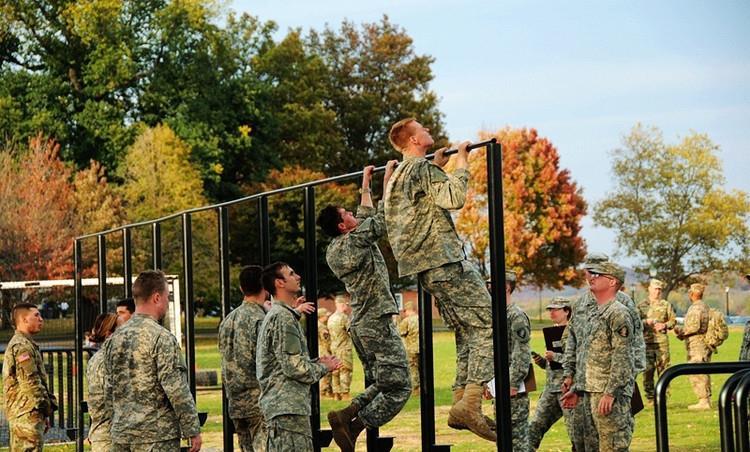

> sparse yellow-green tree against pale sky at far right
[594,124,750,296]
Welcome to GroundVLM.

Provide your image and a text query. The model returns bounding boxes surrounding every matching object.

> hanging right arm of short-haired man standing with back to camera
[154,332,201,438]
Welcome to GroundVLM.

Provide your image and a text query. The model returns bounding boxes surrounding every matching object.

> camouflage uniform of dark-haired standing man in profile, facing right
[256,301,328,452]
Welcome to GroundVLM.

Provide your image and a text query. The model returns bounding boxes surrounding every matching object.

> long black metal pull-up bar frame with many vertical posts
[74,138,512,451]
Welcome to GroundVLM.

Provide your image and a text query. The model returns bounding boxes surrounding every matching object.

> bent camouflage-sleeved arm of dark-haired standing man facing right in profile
[274,323,328,385]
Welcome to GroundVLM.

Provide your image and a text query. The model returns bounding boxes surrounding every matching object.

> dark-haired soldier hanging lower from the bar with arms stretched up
[318,160,411,451]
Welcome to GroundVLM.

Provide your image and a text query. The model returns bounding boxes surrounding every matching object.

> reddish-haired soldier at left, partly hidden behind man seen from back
[86,313,120,452]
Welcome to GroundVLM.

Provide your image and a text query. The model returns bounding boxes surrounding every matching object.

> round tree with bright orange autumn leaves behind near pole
[456,128,586,289]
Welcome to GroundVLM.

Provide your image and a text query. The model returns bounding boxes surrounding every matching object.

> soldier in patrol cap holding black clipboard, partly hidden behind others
[529,297,573,450]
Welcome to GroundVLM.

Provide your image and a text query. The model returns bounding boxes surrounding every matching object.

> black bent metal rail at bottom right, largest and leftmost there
[654,361,750,452]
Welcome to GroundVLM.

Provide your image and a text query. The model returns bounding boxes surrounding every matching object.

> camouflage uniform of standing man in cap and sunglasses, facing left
[584,300,635,452]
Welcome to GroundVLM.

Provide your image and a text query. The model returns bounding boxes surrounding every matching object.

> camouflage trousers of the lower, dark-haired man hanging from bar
[350,315,411,428]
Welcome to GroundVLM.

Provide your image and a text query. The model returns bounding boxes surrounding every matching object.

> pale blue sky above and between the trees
[228,0,750,264]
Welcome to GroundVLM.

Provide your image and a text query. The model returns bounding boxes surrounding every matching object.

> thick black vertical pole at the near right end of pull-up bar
[486,142,513,451]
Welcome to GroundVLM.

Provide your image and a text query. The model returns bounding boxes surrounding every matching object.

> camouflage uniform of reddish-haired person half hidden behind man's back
[86,352,112,452]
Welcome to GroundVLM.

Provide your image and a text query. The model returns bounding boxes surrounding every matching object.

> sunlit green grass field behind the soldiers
[22,327,743,452]
